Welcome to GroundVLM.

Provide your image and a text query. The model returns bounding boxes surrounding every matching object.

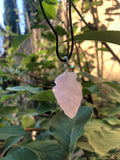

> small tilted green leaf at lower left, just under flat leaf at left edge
[4,136,22,150]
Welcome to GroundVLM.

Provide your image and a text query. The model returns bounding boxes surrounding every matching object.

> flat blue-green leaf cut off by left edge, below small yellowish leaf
[0,126,25,139]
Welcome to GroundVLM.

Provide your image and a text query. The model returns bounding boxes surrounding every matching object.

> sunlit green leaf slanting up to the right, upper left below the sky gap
[11,33,32,53]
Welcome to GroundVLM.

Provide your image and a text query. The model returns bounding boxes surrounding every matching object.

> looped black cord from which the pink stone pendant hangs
[39,0,74,62]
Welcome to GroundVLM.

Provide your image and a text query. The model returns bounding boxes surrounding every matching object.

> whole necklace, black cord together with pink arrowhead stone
[39,0,82,119]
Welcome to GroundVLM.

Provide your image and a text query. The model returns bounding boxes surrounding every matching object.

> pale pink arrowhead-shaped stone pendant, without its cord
[52,71,82,119]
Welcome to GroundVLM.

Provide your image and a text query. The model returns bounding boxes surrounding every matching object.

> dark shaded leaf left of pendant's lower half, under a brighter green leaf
[37,101,56,114]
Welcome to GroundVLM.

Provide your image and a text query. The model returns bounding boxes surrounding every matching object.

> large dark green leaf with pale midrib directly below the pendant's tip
[50,106,92,154]
